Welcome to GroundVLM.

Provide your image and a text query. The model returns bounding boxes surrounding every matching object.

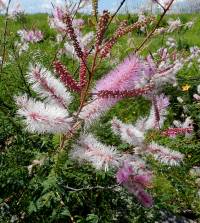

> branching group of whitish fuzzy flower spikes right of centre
[112,96,183,165]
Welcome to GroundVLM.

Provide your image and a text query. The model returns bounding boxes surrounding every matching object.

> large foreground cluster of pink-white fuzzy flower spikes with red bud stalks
[16,1,197,207]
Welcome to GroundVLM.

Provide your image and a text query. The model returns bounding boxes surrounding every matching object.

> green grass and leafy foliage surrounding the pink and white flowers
[0,14,200,223]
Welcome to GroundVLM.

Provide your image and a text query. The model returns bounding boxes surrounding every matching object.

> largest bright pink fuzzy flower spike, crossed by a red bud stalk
[80,55,142,124]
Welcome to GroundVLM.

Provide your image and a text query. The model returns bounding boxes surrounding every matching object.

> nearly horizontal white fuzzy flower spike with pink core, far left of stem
[16,95,73,133]
